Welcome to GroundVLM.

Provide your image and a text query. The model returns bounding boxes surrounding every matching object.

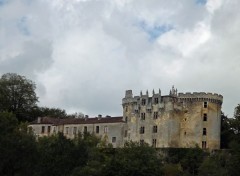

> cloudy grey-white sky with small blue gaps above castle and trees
[0,0,240,117]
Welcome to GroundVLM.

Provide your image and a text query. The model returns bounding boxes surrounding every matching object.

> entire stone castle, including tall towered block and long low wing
[30,87,223,150]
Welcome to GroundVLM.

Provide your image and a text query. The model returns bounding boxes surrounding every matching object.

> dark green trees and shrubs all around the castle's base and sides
[0,74,240,176]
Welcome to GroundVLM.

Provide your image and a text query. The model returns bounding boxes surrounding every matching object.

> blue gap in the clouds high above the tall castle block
[139,22,173,41]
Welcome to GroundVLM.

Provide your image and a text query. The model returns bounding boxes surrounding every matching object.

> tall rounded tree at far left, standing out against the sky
[0,73,38,121]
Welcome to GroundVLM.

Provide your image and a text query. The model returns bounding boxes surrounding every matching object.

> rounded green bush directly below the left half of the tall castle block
[103,142,162,176]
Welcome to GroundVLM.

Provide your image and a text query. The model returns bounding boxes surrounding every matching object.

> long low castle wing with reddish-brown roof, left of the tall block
[29,115,126,147]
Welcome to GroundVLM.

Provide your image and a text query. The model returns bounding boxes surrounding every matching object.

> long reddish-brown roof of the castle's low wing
[30,116,124,125]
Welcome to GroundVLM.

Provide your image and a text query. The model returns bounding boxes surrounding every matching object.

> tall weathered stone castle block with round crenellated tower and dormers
[122,87,223,149]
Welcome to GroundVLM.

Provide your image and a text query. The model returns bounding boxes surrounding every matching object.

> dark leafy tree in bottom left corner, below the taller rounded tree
[0,112,37,176]
